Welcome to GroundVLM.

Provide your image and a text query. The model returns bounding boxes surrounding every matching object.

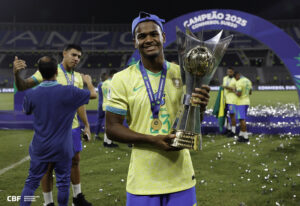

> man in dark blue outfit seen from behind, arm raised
[20,56,97,206]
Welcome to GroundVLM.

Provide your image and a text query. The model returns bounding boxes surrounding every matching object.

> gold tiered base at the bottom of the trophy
[171,130,201,150]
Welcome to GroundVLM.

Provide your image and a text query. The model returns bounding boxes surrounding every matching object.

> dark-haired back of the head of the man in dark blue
[38,56,57,79]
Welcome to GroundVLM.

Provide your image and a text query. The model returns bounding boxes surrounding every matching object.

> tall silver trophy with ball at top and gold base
[171,27,233,150]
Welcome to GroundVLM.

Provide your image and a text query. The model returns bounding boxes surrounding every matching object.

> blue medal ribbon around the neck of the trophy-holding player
[139,61,167,119]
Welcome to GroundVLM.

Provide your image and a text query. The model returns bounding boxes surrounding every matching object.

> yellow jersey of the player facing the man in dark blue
[31,64,83,129]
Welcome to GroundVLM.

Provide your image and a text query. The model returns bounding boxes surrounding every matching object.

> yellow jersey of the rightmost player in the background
[236,76,252,105]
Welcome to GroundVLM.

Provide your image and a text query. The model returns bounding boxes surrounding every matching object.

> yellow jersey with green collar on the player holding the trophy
[106,62,196,195]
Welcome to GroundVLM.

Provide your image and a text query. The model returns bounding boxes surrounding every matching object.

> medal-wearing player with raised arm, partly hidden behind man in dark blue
[14,44,91,206]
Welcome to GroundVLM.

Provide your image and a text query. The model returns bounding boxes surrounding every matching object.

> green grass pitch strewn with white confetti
[0,91,300,206]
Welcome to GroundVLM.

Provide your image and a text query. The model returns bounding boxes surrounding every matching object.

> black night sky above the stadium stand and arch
[0,0,300,24]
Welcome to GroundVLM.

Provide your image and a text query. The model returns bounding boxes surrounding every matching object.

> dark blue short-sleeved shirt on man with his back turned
[23,81,90,161]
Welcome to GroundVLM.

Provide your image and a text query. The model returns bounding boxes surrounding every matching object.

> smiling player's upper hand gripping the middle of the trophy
[192,85,210,112]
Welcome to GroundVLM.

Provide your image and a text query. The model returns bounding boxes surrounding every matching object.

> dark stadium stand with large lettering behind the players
[0,21,300,87]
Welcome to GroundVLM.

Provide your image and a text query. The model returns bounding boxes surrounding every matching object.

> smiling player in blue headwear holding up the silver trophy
[106,12,209,206]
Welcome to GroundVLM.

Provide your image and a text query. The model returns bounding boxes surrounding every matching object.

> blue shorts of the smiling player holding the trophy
[126,187,197,206]
